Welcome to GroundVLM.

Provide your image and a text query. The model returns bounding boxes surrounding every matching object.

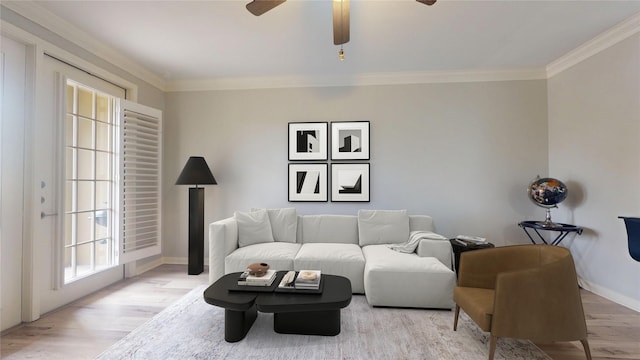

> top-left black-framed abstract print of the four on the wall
[288,122,329,161]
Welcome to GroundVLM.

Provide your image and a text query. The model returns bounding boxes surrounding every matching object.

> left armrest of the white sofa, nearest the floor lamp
[209,217,238,284]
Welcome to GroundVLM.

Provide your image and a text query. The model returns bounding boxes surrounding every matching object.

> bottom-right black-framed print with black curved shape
[331,163,370,202]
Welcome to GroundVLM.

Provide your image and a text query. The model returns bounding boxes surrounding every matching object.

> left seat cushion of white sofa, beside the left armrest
[224,242,300,274]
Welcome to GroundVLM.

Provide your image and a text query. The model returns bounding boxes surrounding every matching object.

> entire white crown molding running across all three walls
[2,1,640,92]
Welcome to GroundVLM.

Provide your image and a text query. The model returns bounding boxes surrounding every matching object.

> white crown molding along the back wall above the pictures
[167,68,546,91]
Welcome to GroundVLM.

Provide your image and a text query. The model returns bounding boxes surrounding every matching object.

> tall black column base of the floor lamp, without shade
[188,187,204,275]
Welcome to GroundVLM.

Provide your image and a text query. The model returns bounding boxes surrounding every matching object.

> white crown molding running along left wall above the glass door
[2,1,166,91]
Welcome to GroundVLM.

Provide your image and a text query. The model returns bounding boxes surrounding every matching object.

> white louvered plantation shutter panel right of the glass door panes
[119,100,162,264]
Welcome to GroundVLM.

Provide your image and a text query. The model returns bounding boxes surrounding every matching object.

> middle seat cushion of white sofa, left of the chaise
[293,243,365,293]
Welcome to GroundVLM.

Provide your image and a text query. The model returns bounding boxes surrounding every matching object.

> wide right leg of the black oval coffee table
[273,309,340,336]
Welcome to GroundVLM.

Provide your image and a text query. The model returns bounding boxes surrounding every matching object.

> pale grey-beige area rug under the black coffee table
[97,286,551,360]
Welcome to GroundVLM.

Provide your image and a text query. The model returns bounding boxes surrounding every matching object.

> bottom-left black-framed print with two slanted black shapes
[288,164,329,202]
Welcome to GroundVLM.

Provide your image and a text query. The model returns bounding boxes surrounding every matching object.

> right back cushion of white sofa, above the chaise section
[358,210,409,246]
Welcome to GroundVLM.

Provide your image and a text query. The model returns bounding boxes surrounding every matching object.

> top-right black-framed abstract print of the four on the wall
[331,121,370,160]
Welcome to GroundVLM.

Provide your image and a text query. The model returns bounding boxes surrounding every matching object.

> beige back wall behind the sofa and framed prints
[163,80,548,257]
